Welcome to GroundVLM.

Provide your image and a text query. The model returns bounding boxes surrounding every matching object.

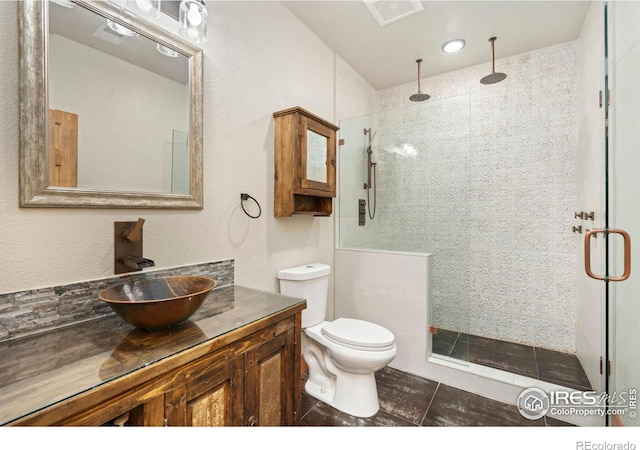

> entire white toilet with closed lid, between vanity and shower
[278,263,397,417]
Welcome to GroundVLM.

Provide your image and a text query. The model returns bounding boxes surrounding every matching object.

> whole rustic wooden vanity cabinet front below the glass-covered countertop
[15,308,301,426]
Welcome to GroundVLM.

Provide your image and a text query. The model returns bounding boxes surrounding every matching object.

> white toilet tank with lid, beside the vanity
[278,263,331,328]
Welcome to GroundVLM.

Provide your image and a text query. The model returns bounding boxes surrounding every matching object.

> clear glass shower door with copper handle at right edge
[605,2,640,426]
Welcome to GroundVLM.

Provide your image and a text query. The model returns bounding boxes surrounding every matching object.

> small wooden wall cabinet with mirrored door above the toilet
[273,106,339,217]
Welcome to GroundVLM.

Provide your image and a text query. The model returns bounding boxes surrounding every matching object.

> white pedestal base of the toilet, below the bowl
[304,368,380,417]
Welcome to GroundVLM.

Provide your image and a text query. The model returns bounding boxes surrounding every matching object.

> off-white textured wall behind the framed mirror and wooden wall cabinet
[0,2,372,324]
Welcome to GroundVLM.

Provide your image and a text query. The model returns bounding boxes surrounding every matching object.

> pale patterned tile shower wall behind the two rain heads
[374,42,581,352]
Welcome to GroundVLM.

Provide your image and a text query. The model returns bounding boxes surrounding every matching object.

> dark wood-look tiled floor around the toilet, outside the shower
[300,367,571,427]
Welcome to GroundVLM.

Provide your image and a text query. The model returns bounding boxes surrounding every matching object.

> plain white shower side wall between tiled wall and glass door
[575,2,605,391]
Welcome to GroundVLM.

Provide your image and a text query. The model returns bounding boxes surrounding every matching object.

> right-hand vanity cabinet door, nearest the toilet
[245,328,299,426]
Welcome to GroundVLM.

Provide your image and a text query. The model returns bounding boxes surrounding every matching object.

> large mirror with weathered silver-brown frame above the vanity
[19,0,202,209]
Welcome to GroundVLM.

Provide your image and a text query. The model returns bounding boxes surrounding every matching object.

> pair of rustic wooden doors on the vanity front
[170,314,299,426]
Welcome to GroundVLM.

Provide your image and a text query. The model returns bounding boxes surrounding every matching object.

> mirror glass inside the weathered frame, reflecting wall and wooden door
[48,3,189,194]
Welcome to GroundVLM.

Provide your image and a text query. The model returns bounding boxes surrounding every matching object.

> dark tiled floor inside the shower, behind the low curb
[432,330,591,391]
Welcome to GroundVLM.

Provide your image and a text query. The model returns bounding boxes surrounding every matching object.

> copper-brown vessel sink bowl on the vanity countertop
[98,276,216,330]
